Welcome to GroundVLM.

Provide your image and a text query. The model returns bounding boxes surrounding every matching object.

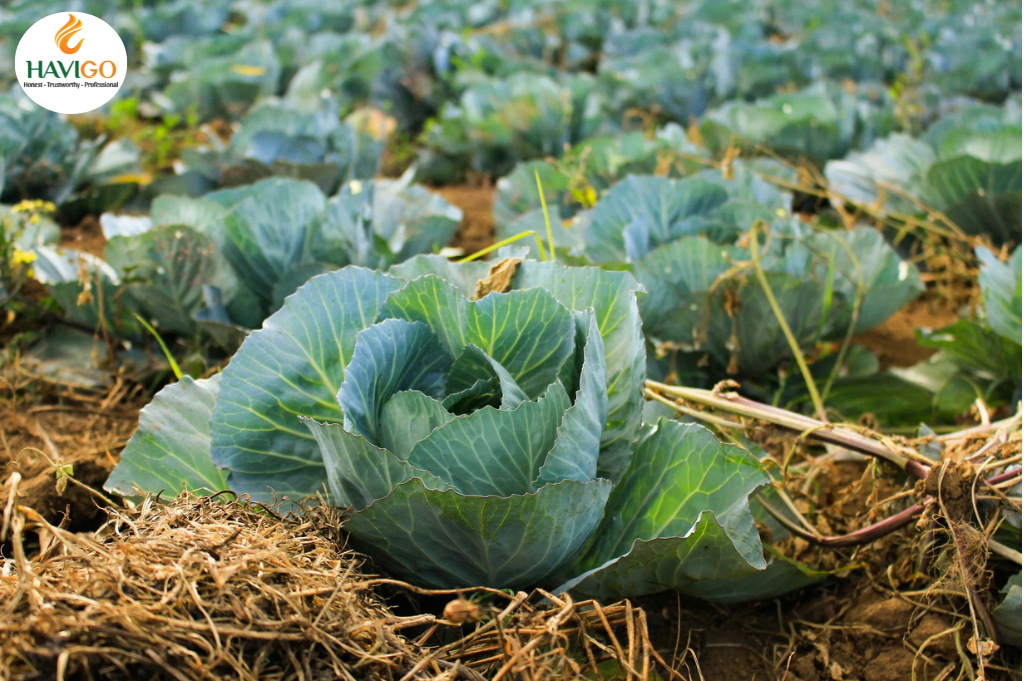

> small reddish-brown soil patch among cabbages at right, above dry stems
[853,292,958,369]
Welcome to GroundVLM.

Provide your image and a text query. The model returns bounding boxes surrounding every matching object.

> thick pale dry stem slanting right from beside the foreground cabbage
[647,381,931,479]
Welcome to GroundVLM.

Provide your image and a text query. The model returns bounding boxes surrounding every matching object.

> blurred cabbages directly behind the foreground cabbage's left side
[20,176,462,350]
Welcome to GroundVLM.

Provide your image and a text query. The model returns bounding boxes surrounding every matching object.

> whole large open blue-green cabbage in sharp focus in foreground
[106,256,778,600]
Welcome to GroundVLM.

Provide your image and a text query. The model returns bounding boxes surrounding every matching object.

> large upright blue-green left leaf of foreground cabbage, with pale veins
[211,267,401,499]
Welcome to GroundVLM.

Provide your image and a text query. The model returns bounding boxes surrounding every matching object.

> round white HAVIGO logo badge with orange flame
[14,12,128,114]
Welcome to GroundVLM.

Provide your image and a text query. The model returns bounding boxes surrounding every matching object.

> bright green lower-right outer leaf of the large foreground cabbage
[558,419,769,599]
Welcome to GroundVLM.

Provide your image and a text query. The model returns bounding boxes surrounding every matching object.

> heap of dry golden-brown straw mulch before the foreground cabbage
[0,481,658,681]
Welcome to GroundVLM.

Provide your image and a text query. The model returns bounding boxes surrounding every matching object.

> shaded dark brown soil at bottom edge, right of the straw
[640,576,974,681]
